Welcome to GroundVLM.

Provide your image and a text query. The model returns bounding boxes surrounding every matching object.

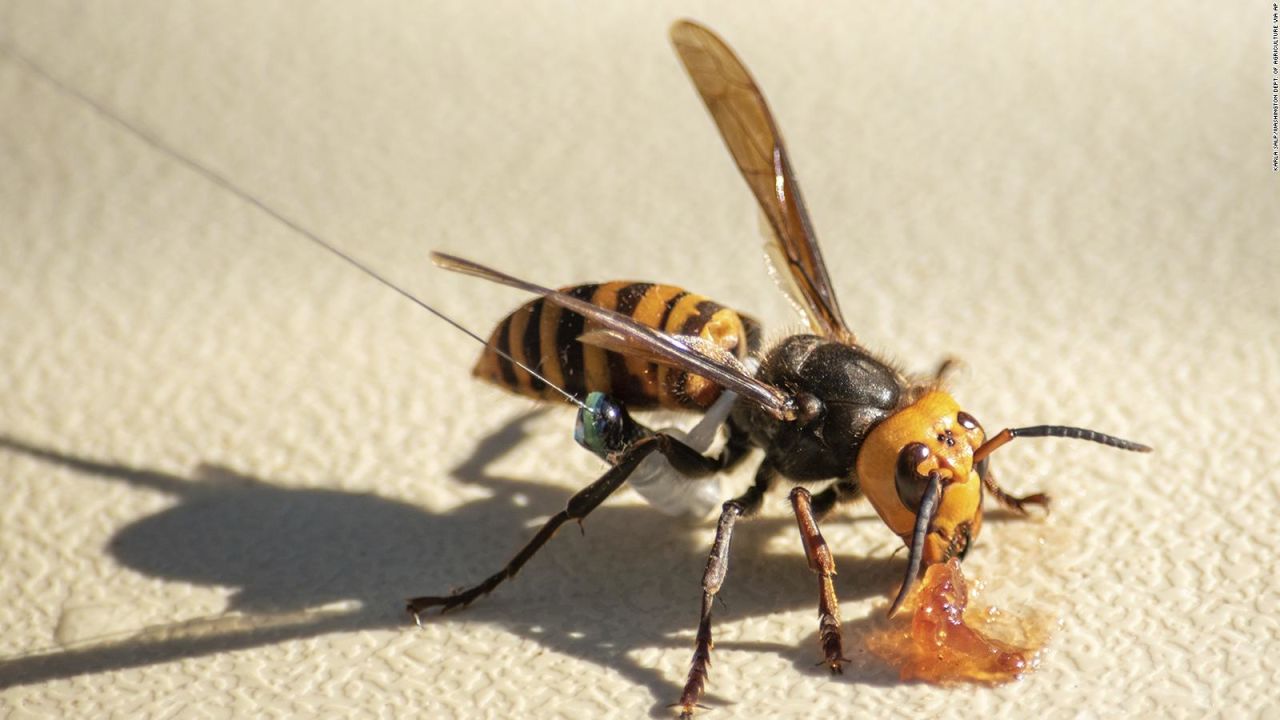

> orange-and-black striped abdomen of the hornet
[474,281,759,410]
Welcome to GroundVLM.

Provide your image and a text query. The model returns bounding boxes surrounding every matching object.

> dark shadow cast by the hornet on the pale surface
[0,410,902,716]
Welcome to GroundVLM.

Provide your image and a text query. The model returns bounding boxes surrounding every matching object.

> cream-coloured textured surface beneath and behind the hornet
[0,0,1280,719]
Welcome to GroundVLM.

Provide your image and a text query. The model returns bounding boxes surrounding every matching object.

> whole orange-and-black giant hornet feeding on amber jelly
[408,20,1151,717]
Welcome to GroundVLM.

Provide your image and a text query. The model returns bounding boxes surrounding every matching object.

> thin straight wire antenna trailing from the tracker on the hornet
[0,36,591,413]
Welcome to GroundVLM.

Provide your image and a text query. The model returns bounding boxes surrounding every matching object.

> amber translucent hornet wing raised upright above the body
[671,20,854,342]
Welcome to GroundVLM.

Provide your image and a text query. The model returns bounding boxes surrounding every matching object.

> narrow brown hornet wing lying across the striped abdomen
[431,252,796,420]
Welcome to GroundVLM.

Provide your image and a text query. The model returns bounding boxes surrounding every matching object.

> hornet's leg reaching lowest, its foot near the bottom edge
[676,460,777,720]
